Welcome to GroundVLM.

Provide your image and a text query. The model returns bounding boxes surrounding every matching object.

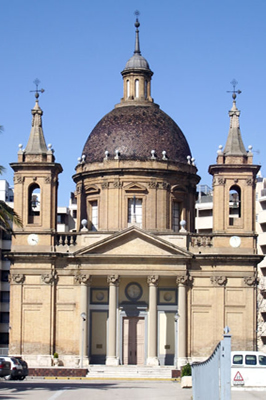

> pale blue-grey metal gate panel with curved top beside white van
[191,327,231,400]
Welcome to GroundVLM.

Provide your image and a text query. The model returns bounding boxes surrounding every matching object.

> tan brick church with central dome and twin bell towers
[9,20,261,367]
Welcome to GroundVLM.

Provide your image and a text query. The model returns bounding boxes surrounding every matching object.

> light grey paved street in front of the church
[0,378,266,400]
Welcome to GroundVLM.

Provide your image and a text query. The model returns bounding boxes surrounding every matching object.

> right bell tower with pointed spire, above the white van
[209,90,260,247]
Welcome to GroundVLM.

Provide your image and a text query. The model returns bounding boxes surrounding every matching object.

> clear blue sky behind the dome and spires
[0,0,266,206]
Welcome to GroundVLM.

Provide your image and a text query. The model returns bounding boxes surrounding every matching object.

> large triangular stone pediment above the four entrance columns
[75,226,192,259]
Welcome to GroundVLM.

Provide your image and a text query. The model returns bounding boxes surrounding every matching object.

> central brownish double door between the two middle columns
[123,317,145,365]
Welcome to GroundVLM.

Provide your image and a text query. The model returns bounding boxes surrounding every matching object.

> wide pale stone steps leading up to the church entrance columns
[87,365,175,379]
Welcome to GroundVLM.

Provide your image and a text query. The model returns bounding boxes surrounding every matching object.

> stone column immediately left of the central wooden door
[106,275,119,365]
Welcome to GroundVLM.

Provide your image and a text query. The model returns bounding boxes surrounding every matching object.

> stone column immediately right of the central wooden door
[147,275,159,366]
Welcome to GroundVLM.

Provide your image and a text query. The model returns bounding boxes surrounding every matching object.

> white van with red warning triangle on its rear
[231,351,266,387]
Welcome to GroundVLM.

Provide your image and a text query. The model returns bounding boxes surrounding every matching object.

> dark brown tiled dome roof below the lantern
[82,104,191,163]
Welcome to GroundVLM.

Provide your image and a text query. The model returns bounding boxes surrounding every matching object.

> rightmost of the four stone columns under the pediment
[176,275,189,368]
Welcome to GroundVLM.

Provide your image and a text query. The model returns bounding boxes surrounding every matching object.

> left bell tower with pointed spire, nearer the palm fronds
[10,84,62,251]
